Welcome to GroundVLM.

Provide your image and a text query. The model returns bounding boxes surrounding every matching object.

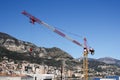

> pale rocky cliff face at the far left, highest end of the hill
[0,32,45,57]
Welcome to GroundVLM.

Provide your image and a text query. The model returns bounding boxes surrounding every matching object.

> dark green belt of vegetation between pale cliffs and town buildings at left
[0,47,61,67]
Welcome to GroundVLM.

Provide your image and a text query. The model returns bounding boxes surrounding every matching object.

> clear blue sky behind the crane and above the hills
[0,0,120,59]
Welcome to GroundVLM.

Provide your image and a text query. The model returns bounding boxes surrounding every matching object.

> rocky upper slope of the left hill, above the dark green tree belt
[0,32,79,67]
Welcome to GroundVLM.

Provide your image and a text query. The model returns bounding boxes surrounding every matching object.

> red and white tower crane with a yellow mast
[22,11,94,80]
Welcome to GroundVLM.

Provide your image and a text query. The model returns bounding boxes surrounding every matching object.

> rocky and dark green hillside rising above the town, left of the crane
[0,32,79,66]
